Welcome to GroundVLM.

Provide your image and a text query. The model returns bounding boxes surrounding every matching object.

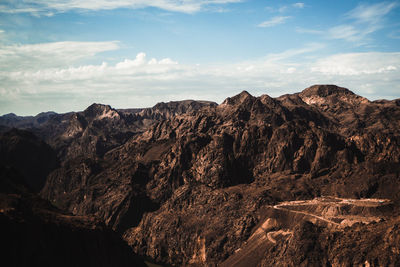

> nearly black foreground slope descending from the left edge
[0,166,146,266]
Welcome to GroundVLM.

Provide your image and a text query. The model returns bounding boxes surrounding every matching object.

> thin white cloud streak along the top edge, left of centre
[0,0,241,15]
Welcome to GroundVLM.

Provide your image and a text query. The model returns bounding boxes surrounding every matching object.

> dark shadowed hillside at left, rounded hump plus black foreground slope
[0,129,146,266]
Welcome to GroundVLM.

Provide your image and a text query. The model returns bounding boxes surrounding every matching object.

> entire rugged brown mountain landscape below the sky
[0,85,400,267]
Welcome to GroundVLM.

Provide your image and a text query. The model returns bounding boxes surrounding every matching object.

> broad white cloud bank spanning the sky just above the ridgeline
[0,42,400,114]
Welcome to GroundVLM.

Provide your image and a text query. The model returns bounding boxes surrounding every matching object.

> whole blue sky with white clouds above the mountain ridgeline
[0,0,400,115]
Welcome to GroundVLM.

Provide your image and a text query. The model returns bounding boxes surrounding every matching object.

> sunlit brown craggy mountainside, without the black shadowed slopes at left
[2,85,400,266]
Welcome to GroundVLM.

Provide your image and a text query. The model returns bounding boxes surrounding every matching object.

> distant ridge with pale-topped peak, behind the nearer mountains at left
[0,100,216,162]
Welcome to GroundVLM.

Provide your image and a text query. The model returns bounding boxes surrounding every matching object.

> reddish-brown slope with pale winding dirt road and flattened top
[220,197,400,266]
